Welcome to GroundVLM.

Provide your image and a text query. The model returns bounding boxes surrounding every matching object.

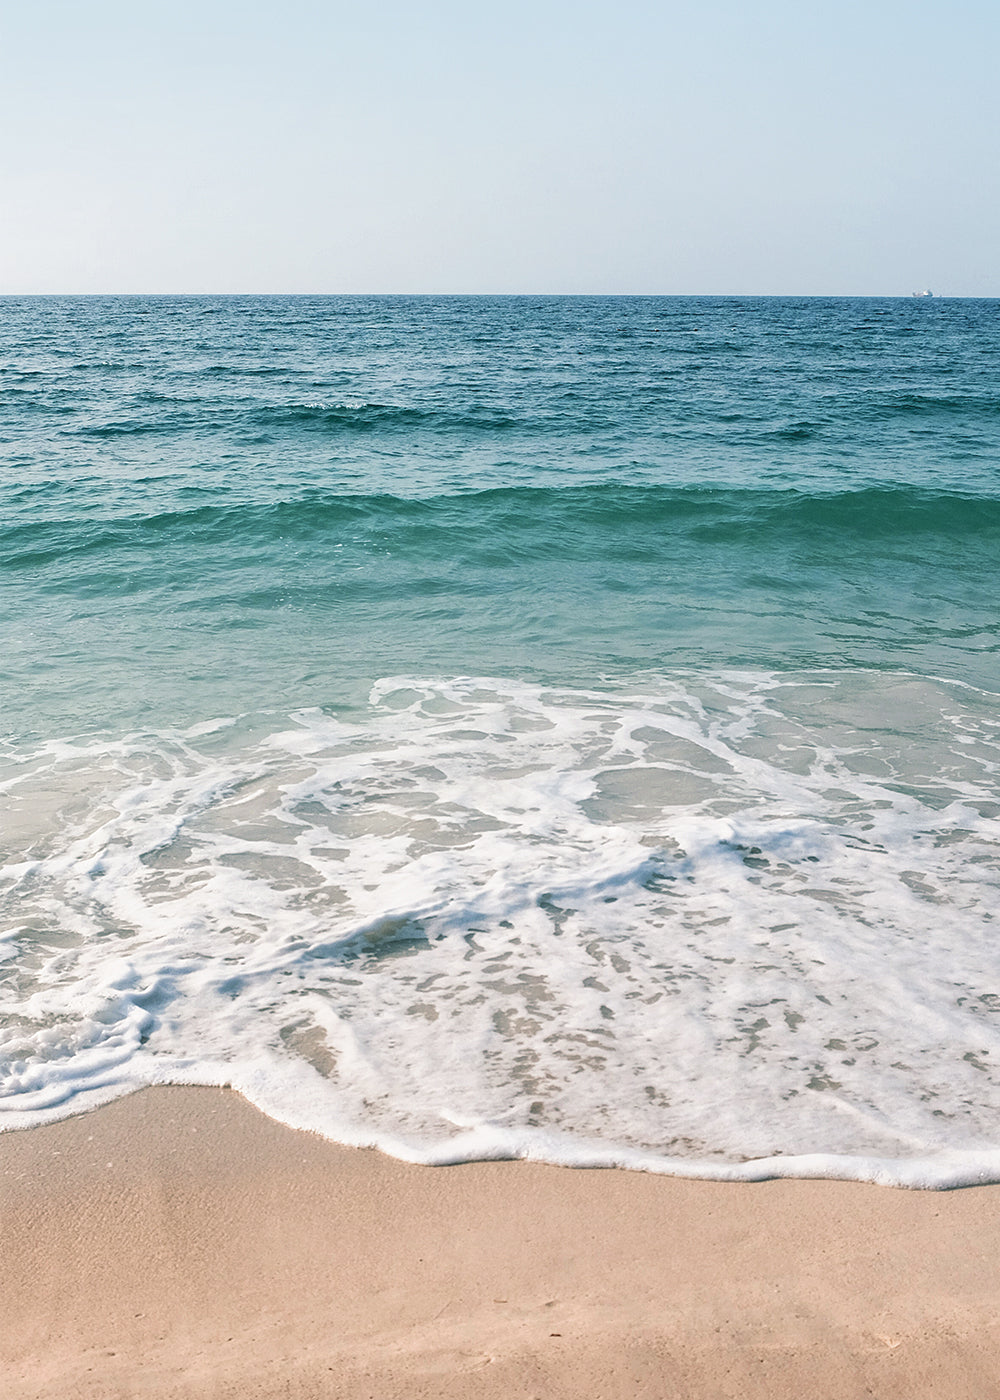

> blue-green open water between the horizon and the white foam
[0,298,1000,732]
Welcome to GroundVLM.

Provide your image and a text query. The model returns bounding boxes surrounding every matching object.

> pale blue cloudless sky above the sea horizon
[0,0,1000,295]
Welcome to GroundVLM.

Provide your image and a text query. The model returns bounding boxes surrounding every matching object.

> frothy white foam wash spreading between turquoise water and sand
[0,673,1000,1186]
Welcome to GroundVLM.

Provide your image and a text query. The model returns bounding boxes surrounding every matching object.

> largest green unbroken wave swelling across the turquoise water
[0,483,1000,570]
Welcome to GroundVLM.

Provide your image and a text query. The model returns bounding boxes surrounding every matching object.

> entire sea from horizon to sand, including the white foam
[0,297,1000,1186]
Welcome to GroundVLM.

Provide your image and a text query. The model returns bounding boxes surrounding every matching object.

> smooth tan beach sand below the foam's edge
[0,1088,1000,1400]
